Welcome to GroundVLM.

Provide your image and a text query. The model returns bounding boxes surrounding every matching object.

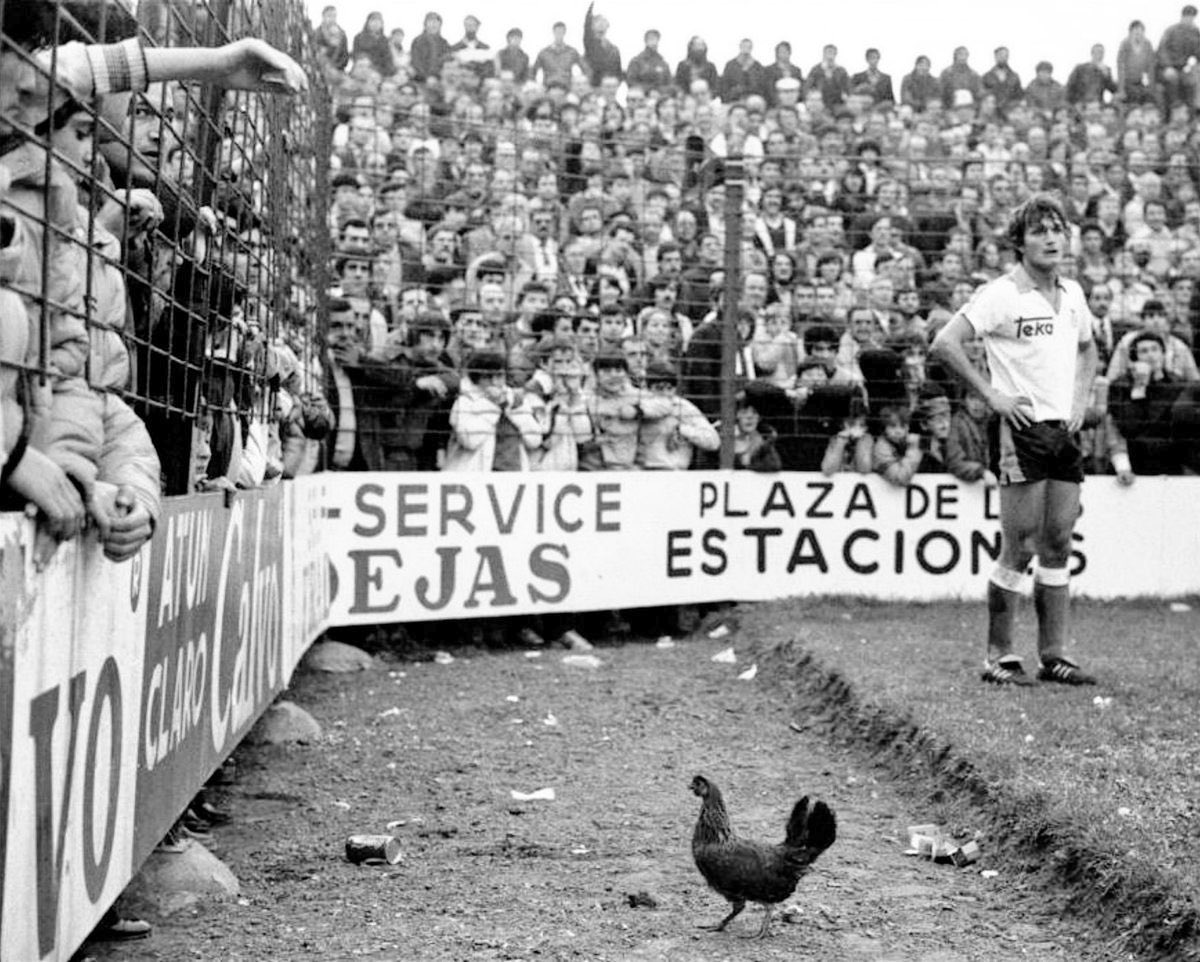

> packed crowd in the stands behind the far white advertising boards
[316,6,1200,485]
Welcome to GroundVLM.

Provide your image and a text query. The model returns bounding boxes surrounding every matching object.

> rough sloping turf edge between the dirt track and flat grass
[766,641,1200,962]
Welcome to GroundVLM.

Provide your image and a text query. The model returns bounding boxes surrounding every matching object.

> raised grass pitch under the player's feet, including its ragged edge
[742,600,1200,960]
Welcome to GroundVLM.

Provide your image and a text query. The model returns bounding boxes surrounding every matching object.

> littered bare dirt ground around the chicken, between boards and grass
[88,635,1118,962]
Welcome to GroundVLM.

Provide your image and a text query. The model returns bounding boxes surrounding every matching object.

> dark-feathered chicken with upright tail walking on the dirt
[691,775,838,938]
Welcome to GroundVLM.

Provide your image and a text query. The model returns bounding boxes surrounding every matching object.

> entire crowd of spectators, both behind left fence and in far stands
[11,4,1200,544]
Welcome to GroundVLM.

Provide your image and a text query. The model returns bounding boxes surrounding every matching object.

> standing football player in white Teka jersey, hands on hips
[932,194,1097,685]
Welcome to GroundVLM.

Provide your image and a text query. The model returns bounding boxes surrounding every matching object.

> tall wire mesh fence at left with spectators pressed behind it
[0,0,330,504]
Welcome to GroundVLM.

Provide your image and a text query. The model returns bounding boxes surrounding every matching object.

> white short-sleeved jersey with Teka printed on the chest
[959,265,1093,421]
